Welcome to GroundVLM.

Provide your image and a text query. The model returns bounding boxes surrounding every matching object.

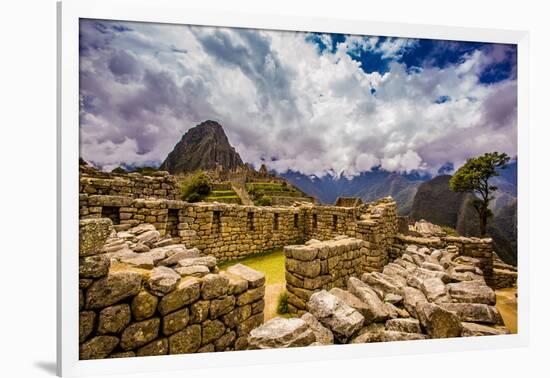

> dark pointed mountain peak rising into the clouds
[160,120,243,174]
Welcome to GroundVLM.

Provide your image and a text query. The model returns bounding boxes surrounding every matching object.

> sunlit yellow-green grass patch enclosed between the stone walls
[218,248,286,285]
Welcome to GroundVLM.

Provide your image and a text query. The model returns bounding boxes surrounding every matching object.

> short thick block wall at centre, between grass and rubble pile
[285,236,368,313]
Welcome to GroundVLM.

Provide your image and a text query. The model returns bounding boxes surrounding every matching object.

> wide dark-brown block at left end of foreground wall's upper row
[86,271,141,309]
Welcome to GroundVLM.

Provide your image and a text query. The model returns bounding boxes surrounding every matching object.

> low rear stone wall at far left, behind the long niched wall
[80,168,180,200]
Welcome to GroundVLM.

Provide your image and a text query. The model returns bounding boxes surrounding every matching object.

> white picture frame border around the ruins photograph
[57,0,529,376]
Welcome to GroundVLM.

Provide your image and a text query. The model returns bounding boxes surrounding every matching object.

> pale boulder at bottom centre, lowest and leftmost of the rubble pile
[248,317,316,349]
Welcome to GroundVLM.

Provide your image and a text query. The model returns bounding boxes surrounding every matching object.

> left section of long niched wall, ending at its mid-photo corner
[80,195,305,261]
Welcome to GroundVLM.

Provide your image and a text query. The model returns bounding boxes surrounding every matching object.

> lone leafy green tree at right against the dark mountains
[449,152,510,237]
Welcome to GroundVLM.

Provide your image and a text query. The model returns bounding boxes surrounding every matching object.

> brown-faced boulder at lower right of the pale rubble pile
[416,302,462,339]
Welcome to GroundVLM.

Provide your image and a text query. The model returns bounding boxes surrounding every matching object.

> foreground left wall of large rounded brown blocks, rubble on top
[79,218,265,359]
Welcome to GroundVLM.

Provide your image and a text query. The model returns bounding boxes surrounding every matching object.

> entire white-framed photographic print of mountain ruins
[58,1,529,375]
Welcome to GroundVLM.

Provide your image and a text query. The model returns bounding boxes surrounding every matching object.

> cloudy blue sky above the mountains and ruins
[79,19,517,177]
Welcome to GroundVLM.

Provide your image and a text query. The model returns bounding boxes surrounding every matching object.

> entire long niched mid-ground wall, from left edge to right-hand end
[80,194,402,264]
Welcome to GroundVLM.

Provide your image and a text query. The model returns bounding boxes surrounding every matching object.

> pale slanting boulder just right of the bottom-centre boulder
[307,290,365,342]
